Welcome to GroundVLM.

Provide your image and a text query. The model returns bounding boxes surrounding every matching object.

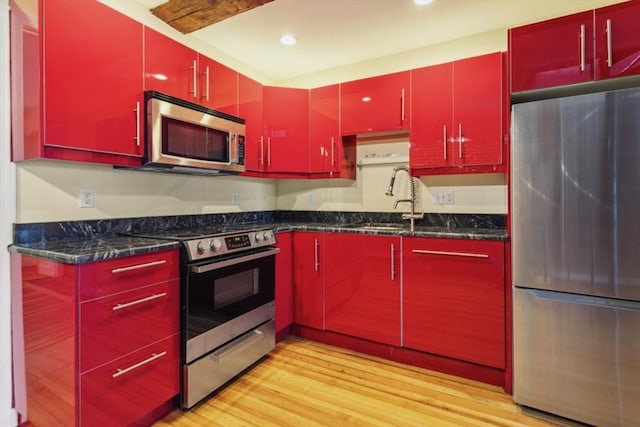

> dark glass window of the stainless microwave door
[162,117,229,163]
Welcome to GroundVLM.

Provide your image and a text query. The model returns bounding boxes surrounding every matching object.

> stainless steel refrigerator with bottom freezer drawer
[511,89,640,426]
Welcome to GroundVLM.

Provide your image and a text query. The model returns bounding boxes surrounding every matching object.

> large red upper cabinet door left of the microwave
[41,0,143,156]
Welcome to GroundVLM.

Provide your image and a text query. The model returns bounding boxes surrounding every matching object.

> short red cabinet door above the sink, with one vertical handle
[340,71,411,135]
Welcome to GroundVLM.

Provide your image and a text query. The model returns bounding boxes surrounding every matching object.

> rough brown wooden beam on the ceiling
[151,0,273,34]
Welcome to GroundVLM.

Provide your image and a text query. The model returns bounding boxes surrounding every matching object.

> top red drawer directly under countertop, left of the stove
[80,250,180,301]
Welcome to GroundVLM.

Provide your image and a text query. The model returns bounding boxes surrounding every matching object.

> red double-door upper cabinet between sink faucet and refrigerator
[410,52,504,175]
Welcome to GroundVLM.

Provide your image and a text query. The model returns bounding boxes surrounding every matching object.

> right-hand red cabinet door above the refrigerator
[595,1,640,79]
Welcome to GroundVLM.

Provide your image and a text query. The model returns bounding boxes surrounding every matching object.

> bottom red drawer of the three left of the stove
[80,334,180,426]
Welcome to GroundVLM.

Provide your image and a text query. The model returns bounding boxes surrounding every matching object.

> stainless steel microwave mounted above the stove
[143,91,246,174]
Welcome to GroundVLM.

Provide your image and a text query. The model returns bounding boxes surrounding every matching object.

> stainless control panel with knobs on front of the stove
[184,230,276,261]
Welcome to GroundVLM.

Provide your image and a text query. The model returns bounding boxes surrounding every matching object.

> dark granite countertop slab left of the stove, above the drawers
[9,236,180,264]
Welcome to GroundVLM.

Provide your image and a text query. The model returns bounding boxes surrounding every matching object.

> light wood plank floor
[155,337,555,427]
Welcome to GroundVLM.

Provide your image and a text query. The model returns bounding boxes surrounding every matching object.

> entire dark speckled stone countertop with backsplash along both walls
[9,211,508,264]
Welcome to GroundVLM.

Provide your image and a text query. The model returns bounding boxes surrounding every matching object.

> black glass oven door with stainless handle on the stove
[183,247,280,363]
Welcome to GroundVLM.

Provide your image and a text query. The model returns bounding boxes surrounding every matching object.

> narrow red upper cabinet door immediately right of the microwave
[238,74,266,172]
